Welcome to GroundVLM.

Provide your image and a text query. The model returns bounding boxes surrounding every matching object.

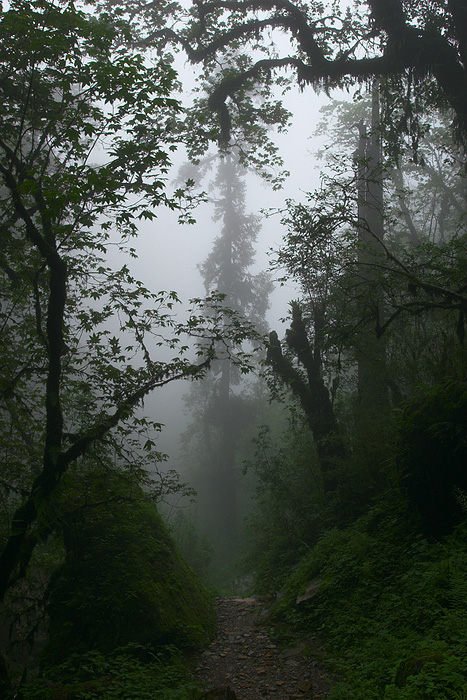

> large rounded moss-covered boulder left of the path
[44,484,215,664]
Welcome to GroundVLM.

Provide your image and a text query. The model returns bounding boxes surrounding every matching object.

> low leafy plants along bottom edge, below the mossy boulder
[17,644,196,700]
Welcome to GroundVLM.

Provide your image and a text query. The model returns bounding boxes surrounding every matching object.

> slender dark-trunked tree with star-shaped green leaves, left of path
[0,0,260,612]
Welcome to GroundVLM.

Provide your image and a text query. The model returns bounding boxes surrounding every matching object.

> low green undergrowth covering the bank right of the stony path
[275,492,467,700]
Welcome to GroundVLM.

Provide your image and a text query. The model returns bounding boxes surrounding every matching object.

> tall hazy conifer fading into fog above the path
[181,152,272,572]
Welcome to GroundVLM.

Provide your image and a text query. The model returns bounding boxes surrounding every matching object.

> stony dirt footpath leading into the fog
[195,597,329,700]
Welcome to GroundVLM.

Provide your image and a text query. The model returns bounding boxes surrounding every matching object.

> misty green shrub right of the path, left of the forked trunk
[244,407,323,593]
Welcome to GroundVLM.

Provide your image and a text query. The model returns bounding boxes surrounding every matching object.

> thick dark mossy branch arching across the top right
[169,0,467,143]
